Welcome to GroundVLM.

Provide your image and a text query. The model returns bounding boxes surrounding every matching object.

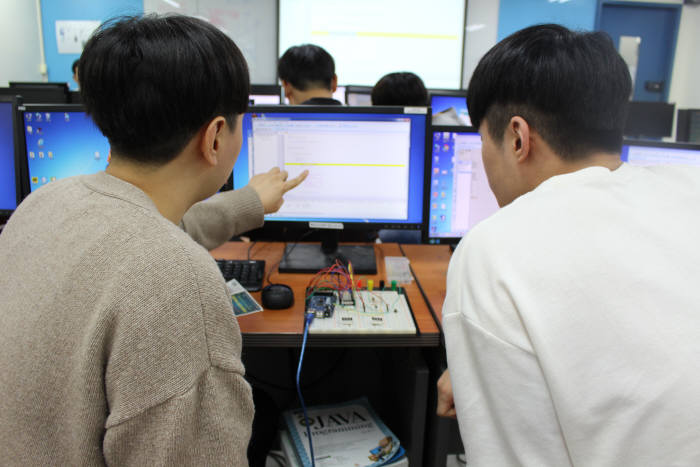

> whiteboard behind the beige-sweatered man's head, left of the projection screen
[143,0,277,84]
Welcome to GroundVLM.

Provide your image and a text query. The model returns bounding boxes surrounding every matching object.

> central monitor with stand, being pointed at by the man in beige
[233,106,430,274]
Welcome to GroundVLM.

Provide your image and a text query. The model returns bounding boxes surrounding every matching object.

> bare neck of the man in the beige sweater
[105,156,203,225]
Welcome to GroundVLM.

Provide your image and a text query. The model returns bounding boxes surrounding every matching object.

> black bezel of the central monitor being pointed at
[238,105,431,231]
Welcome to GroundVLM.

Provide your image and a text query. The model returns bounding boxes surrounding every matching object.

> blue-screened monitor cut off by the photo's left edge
[0,96,19,224]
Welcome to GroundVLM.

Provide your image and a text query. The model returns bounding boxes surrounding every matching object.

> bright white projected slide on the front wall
[279,0,465,89]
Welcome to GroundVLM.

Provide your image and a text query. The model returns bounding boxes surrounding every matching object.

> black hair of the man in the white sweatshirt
[467,24,632,160]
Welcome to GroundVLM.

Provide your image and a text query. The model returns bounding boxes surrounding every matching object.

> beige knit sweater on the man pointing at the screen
[0,173,263,467]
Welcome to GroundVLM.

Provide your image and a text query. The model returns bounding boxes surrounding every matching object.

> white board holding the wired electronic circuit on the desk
[309,290,416,334]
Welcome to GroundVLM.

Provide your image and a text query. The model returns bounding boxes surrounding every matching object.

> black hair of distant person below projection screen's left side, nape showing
[277,44,335,91]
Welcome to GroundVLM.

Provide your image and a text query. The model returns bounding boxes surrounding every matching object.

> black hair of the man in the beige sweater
[79,15,250,165]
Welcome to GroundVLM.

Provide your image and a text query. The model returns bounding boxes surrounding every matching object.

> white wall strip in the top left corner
[0,0,42,87]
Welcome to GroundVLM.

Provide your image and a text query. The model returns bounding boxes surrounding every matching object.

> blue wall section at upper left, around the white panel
[40,0,143,89]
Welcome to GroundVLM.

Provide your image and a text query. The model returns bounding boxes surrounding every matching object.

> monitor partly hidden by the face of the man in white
[424,126,498,244]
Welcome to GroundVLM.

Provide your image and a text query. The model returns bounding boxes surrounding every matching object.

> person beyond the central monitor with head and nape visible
[277,44,342,105]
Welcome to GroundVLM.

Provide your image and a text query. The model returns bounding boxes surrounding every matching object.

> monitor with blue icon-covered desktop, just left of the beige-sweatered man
[18,104,109,196]
